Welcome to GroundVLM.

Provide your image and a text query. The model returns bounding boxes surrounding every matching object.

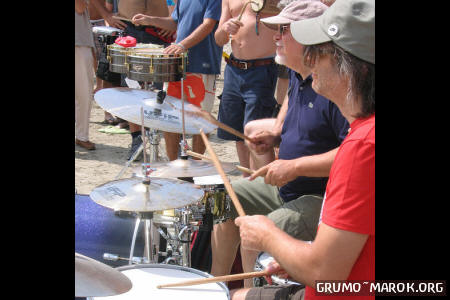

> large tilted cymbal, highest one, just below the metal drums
[94,87,217,134]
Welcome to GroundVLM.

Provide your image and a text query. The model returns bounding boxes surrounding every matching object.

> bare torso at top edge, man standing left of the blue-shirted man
[118,0,169,19]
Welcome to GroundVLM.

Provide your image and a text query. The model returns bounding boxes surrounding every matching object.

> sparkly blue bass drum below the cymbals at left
[75,195,156,267]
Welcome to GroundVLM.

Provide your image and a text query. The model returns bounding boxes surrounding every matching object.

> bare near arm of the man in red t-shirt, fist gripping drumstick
[235,216,368,287]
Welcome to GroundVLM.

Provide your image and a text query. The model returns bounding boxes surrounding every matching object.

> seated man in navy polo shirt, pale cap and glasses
[211,0,349,287]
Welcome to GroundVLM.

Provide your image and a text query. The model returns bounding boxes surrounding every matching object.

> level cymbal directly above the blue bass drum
[89,177,204,212]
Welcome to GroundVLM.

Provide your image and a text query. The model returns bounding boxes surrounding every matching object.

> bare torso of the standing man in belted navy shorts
[227,0,276,59]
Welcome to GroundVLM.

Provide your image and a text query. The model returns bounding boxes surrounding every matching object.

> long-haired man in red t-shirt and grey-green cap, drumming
[231,0,375,300]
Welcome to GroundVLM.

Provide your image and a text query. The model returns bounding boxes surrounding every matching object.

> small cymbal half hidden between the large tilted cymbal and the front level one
[133,158,236,178]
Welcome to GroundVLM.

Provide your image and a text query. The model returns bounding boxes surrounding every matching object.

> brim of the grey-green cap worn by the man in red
[291,16,331,45]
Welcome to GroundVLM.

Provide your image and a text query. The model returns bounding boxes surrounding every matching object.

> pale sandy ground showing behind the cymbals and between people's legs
[75,45,241,194]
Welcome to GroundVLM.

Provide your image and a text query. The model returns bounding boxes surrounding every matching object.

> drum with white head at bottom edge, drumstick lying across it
[88,264,230,300]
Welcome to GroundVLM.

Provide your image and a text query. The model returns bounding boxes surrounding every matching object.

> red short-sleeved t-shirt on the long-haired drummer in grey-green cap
[305,115,375,300]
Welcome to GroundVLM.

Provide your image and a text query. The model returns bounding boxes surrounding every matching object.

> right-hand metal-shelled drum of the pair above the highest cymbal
[127,47,187,82]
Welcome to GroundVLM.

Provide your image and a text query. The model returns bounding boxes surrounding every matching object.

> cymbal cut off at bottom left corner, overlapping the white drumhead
[75,253,133,297]
